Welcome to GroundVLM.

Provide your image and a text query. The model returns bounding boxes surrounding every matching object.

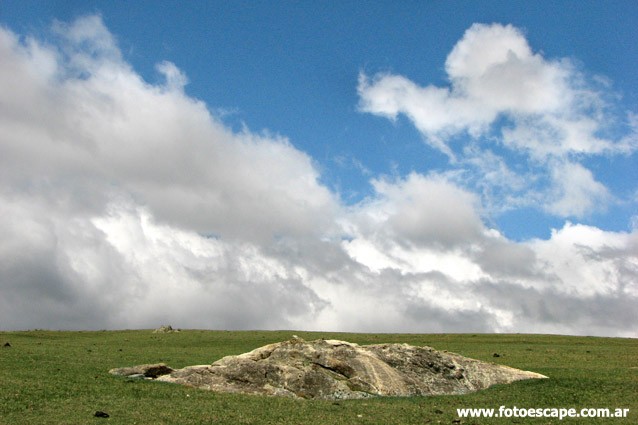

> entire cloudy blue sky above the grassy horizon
[0,0,638,337]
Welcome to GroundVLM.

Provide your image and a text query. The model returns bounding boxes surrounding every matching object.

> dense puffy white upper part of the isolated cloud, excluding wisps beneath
[359,24,571,152]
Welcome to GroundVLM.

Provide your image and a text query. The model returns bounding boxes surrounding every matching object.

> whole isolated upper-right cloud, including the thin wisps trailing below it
[358,24,638,217]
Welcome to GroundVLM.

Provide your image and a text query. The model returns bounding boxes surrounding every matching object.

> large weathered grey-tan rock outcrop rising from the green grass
[110,338,546,399]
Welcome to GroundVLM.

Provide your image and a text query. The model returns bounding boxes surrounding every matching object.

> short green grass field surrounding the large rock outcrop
[0,330,638,425]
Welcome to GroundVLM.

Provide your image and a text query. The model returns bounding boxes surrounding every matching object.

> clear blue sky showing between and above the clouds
[1,1,638,240]
